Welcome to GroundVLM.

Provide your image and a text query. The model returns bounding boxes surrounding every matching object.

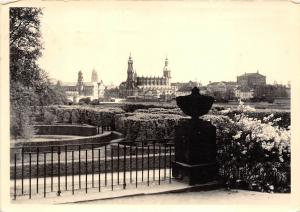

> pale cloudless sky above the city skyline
[39,1,300,86]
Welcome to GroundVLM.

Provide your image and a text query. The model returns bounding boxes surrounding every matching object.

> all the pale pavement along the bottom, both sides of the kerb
[11,170,290,205]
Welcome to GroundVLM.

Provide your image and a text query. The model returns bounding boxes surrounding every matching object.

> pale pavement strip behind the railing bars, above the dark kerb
[10,169,173,203]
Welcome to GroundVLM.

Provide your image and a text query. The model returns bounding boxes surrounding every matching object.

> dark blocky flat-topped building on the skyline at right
[237,71,266,89]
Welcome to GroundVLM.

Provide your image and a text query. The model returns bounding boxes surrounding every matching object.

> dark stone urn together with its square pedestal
[172,87,217,185]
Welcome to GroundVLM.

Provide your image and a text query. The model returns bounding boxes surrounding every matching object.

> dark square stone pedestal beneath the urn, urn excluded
[172,118,218,185]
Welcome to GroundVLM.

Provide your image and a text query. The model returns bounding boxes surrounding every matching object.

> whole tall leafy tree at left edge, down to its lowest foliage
[9,7,64,138]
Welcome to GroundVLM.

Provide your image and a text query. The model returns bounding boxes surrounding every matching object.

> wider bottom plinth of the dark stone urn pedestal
[172,161,218,185]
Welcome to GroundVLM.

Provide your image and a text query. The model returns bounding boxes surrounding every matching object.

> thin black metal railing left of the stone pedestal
[10,139,174,199]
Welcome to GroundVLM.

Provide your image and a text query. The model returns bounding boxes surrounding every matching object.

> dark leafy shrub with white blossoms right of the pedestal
[211,105,290,192]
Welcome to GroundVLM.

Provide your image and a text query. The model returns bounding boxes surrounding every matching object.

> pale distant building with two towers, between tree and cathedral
[57,70,105,102]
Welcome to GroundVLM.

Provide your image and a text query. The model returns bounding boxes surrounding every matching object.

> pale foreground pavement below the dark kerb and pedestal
[82,189,291,207]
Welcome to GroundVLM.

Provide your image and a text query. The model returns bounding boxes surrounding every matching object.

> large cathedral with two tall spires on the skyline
[120,55,176,98]
